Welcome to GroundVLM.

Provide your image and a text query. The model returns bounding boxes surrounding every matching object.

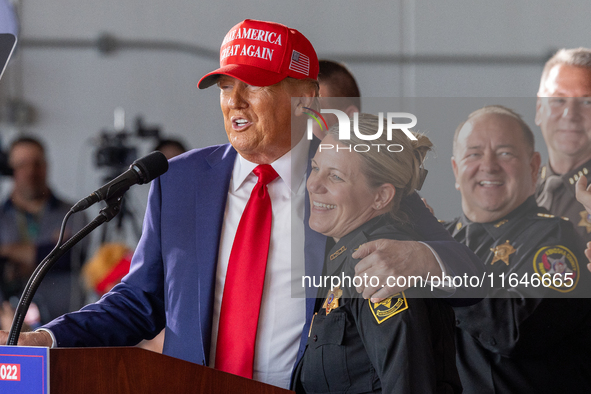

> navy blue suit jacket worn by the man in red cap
[45,144,487,365]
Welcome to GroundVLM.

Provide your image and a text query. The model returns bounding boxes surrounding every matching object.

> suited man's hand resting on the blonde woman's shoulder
[353,239,441,302]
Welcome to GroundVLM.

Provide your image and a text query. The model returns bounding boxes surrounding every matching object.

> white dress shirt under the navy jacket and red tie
[209,138,310,388]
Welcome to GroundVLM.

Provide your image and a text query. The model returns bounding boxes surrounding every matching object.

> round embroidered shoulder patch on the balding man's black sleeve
[534,245,580,293]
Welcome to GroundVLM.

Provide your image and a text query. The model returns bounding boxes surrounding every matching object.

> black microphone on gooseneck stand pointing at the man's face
[70,151,168,213]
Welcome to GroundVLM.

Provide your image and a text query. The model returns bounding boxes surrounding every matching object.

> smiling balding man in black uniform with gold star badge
[446,106,591,394]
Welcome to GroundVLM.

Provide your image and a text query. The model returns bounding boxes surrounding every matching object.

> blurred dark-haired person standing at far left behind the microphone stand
[0,136,87,322]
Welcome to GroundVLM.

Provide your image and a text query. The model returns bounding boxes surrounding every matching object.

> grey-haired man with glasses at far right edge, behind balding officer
[536,48,591,241]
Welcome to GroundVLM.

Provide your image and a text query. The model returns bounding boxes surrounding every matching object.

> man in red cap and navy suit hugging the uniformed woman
[0,20,486,387]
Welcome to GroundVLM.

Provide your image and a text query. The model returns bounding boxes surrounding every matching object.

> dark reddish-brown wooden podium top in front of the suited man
[49,347,293,394]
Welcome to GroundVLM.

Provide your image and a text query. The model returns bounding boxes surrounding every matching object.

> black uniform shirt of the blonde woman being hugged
[295,216,461,393]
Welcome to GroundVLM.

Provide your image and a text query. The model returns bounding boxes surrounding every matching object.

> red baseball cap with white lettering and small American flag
[197,19,318,89]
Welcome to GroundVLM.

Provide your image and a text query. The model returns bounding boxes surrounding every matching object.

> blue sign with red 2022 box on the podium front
[0,346,49,394]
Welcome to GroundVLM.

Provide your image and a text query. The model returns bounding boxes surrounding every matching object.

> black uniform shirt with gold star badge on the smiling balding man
[446,196,591,394]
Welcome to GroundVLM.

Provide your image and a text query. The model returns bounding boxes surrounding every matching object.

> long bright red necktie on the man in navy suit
[215,164,278,379]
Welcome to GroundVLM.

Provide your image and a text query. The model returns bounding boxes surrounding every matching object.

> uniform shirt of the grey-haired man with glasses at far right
[536,160,591,242]
